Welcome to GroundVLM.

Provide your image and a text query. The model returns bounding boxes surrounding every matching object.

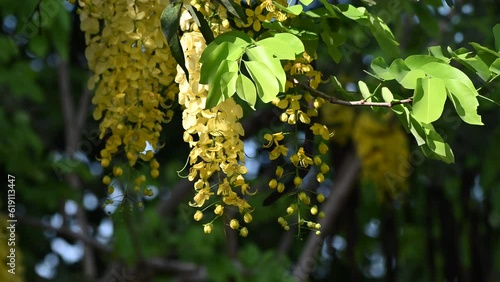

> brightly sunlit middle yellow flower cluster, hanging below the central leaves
[175,7,252,236]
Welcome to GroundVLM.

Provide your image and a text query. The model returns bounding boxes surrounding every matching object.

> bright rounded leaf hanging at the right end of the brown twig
[413,77,446,123]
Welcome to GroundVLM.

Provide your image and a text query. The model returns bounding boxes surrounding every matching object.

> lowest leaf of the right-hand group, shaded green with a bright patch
[422,124,455,164]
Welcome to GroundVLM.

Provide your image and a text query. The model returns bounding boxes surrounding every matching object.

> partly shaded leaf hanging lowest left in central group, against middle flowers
[205,60,238,109]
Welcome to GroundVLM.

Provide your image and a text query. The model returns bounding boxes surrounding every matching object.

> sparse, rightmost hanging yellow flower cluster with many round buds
[264,53,331,235]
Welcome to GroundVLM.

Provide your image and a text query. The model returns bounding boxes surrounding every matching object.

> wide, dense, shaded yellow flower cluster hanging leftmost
[78,0,177,195]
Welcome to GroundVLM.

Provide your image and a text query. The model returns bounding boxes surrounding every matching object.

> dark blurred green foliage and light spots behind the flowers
[0,0,500,281]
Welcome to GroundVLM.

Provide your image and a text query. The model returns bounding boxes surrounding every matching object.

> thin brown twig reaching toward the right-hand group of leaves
[288,76,413,108]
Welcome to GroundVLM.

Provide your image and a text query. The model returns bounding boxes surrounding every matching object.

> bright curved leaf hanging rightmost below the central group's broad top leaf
[245,61,279,103]
